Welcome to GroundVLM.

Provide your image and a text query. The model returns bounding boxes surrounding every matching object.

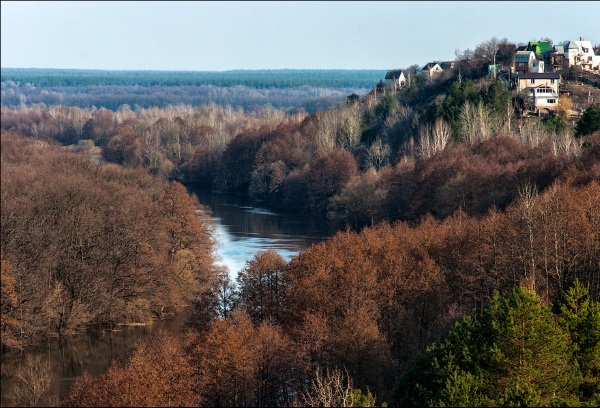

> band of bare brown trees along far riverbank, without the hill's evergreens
[2,101,600,229]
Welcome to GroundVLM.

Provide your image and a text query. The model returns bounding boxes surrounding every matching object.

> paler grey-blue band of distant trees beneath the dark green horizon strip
[2,83,367,113]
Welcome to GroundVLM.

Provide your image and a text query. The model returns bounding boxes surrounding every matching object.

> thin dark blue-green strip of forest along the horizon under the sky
[1,68,386,89]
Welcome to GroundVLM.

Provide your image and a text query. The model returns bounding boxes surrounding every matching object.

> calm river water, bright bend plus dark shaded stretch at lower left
[1,191,333,406]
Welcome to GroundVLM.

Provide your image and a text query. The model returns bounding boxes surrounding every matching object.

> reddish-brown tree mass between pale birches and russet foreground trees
[390,136,565,220]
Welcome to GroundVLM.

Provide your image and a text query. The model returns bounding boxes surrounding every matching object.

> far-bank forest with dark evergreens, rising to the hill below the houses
[2,75,599,228]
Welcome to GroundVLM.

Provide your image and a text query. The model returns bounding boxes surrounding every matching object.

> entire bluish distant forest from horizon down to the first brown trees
[1,68,385,113]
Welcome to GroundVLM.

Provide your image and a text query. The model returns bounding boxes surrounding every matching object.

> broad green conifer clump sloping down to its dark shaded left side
[393,286,581,406]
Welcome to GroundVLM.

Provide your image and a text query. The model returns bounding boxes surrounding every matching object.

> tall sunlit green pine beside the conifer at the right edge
[484,286,579,405]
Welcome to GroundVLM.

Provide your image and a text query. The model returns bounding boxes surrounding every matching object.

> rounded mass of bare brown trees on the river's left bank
[0,131,213,346]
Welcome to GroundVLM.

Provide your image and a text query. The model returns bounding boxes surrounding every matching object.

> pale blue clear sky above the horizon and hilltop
[0,1,600,71]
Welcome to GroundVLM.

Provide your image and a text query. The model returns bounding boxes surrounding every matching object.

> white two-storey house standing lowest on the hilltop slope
[517,72,560,111]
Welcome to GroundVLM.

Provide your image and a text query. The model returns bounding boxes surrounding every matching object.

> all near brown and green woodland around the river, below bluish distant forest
[0,37,600,406]
